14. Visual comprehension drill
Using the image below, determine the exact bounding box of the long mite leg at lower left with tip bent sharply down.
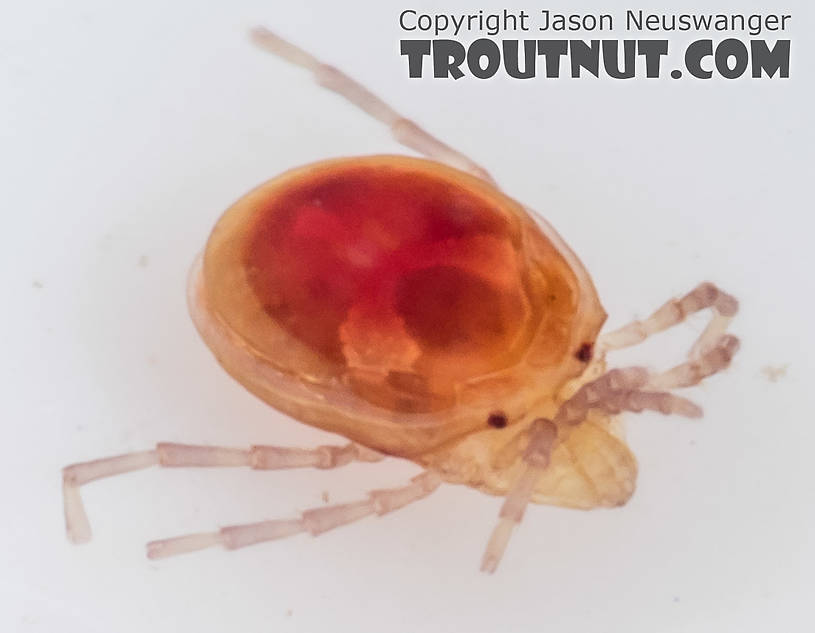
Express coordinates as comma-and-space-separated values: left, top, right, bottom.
62, 443, 383, 543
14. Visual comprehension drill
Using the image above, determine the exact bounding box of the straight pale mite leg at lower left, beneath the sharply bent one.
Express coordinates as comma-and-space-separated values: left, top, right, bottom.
147, 471, 441, 558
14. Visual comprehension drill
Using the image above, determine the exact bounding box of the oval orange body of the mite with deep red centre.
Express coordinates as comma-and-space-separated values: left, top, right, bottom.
191, 156, 605, 457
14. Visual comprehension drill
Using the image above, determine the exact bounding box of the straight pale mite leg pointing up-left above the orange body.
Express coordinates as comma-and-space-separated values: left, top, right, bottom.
251, 27, 495, 184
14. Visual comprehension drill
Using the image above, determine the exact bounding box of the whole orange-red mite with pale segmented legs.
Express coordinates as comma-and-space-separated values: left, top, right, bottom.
63, 29, 738, 572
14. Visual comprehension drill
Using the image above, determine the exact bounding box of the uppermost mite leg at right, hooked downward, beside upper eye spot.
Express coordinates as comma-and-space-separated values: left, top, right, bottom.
597, 282, 739, 359
